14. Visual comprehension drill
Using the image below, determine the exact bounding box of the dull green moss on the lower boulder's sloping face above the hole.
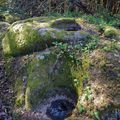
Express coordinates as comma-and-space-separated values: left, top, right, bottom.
25, 53, 75, 109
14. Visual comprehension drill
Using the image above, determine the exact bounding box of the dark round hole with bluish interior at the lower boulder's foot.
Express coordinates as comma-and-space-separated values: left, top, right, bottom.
46, 99, 75, 120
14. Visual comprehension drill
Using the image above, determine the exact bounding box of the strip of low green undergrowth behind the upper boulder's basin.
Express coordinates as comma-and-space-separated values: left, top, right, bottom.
45, 10, 120, 26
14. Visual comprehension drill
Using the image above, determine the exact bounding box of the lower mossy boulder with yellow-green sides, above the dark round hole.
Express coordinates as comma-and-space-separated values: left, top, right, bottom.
14, 48, 88, 110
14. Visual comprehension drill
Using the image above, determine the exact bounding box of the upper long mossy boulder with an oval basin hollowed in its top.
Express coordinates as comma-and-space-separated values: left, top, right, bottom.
2, 17, 89, 56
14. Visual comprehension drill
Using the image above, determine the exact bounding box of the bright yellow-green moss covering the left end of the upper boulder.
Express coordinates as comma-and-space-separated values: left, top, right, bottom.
3, 25, 44, 56
